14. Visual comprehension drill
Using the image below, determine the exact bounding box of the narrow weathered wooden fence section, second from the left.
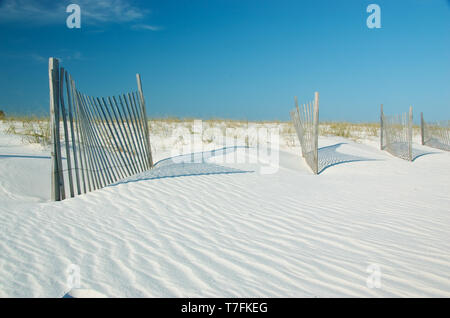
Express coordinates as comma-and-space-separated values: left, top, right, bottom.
291, 92, 319, 174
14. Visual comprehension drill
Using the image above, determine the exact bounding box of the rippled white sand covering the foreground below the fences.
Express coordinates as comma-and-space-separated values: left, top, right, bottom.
0, 121, 450, 297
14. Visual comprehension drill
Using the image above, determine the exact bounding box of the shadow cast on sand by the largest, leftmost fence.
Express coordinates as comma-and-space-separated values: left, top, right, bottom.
108, 147, 254, 187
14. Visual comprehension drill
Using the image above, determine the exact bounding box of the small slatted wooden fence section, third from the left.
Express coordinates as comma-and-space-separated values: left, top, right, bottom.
380, 105, 413, 161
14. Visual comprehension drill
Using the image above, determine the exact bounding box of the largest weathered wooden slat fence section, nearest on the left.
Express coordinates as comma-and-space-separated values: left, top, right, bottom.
49, 58, 153, 201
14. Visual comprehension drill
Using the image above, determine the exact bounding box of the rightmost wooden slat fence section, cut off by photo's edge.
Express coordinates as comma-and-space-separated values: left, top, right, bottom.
420, 113, 450, 151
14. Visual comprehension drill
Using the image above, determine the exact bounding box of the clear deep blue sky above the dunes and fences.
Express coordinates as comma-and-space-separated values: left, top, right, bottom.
0, 0, 450, 121
